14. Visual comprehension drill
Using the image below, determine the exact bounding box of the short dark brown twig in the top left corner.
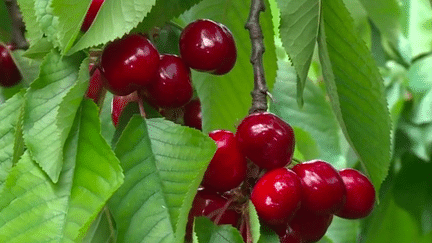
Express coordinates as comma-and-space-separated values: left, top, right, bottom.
4, 0, 28, 49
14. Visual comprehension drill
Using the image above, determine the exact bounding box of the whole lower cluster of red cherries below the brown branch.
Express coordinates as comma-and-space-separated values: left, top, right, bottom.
190, 112, 375, 243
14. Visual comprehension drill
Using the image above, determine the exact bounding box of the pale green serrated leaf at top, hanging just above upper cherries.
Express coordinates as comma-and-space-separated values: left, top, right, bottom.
68, 0, 156, 54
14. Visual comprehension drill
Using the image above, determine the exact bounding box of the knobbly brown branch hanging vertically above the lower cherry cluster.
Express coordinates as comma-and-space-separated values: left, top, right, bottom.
245, 0, 268, 114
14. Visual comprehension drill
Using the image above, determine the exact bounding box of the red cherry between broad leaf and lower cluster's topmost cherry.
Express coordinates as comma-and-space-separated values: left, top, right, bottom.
202, 130, 247, 192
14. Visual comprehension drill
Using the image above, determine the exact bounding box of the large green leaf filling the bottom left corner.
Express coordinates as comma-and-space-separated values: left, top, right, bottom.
0, 100, 123, 243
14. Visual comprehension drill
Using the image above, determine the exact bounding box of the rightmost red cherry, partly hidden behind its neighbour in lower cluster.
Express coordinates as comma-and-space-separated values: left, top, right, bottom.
336, 169, 375, 219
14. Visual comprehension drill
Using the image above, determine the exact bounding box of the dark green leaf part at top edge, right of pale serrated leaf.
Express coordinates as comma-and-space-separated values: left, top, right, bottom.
136, 0, 202, 32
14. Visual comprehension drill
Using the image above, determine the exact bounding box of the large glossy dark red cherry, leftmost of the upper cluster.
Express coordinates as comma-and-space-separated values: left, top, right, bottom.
101, 34, 159, 96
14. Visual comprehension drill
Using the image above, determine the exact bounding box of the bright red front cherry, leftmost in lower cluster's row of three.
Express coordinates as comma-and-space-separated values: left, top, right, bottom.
251, 168, 302, 225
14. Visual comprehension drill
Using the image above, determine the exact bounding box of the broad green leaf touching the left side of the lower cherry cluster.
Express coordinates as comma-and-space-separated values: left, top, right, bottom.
109, 116, 216, 242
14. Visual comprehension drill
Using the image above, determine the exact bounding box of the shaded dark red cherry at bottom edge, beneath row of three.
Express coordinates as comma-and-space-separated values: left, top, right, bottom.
289, 208, 333, 243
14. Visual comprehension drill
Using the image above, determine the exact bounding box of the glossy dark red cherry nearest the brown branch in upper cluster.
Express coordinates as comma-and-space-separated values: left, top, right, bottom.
179, 19, 237, 75
